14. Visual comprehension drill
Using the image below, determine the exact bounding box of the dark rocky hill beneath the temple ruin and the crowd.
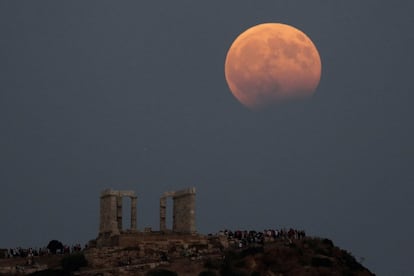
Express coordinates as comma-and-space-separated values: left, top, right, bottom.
0, 232, 374, 276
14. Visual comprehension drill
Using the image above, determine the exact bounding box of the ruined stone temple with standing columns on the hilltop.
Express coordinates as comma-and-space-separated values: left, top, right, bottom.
96, 188, 197, 247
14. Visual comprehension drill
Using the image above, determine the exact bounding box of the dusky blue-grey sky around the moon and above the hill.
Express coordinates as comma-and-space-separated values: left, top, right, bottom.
0, 0, 414, 275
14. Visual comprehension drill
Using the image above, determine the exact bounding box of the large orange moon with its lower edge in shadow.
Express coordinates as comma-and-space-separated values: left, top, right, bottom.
225, 23, 321, 110
